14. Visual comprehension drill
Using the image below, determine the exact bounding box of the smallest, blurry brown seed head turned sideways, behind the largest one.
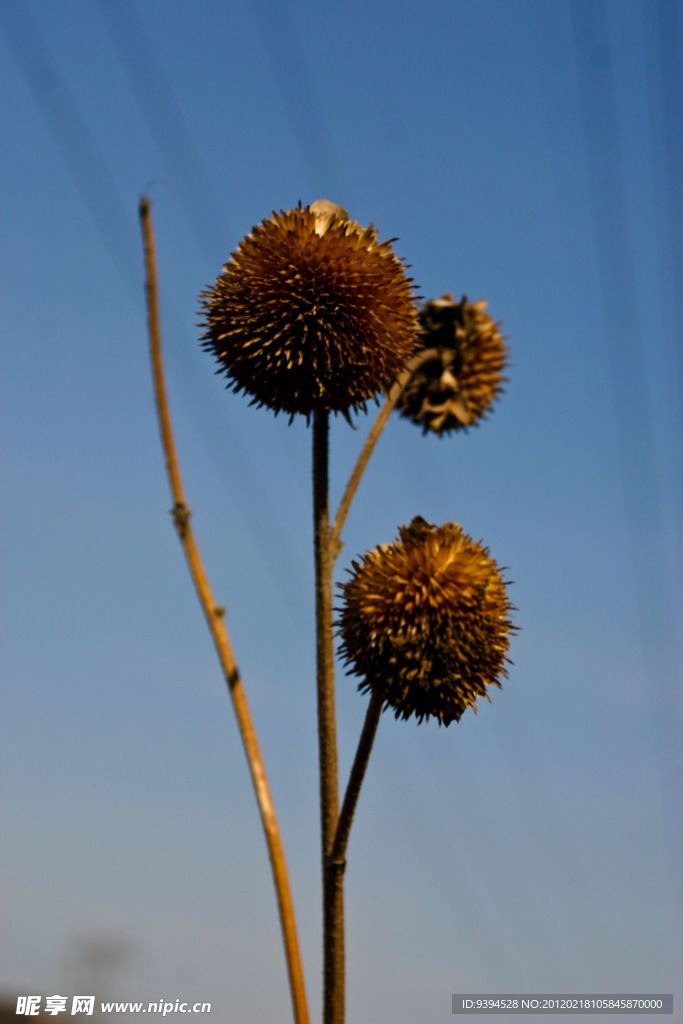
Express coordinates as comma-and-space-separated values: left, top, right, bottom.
398, 294, 508, 435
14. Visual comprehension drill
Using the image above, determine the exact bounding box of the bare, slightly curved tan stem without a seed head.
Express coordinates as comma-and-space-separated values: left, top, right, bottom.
139, 197, 308, 1024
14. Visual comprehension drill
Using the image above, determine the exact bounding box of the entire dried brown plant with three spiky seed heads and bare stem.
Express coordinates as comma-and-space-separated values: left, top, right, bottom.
140, 199, 515, 1024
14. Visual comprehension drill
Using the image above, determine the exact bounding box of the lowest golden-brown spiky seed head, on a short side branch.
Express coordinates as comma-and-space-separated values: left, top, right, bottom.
339, 516, 515, 725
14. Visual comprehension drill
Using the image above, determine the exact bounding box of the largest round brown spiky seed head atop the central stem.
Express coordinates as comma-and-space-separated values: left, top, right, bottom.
201, 200, 418, 417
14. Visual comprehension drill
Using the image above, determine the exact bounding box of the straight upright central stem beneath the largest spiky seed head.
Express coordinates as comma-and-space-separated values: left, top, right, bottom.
313, 411, 344, 1024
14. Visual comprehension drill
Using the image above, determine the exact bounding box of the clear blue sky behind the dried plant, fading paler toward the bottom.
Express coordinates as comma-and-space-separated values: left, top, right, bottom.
0, 0, 683, 1024
